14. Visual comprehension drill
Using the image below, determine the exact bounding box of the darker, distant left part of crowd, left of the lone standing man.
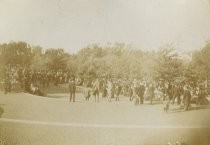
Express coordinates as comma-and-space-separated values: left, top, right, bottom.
0, 65, 80, 95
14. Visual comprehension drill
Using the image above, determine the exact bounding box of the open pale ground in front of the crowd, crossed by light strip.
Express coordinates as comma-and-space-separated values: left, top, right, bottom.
0, 85, 210, 145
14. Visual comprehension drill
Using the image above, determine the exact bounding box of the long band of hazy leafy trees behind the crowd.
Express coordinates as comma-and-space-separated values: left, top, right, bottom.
0, 42, 210, 83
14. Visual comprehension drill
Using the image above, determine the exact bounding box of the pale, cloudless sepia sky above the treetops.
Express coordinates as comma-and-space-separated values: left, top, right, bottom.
0, 0, 210, 52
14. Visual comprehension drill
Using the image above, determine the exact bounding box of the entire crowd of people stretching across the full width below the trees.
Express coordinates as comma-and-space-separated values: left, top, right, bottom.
1, 66, 208, 112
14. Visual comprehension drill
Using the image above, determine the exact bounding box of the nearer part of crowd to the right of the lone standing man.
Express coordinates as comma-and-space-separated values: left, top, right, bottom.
80, 78, 208, 112
